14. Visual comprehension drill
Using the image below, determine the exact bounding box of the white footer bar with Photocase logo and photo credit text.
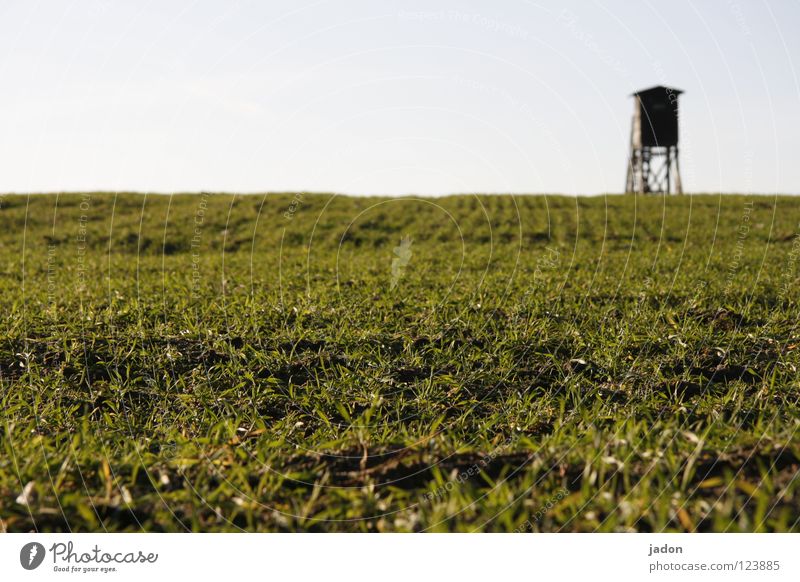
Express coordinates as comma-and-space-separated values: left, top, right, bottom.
0, 534, 800, 582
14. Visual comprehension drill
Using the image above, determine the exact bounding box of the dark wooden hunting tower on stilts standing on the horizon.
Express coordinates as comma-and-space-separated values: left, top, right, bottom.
625, 85, 683, 194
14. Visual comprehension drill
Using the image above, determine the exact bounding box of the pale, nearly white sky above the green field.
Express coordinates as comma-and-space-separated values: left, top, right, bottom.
0, 0, 800, 195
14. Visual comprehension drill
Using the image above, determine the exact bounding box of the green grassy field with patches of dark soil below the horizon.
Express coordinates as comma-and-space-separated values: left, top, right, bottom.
0, 193, 800, 532
